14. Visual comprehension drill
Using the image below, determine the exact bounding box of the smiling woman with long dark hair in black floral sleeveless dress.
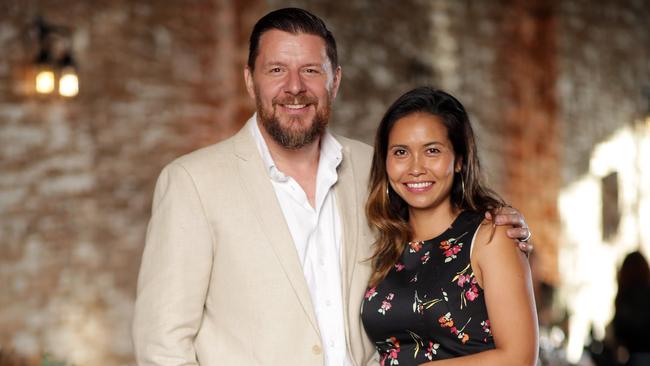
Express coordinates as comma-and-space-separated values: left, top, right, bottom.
361, 87, 538, 366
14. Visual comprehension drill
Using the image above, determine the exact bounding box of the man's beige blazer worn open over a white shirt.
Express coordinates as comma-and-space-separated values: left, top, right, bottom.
133, 123, 374, 366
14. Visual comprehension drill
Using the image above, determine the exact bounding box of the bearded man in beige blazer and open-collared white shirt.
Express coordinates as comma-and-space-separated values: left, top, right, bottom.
133, 8, 528, 366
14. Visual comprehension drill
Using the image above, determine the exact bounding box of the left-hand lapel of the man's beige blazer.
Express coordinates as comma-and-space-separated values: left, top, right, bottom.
233, 125, 320, 336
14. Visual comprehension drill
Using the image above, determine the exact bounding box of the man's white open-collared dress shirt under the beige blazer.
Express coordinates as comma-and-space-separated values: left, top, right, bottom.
248, 114, 352, 366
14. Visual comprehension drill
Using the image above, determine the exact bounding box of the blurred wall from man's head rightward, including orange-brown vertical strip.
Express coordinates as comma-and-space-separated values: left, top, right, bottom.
271, 0, 560, 283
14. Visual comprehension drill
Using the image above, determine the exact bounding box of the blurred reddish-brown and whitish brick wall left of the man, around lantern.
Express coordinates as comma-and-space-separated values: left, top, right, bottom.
0, 0, 263, 365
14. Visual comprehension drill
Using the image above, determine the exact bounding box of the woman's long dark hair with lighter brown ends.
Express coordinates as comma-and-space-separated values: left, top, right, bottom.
366, 87, 504, 286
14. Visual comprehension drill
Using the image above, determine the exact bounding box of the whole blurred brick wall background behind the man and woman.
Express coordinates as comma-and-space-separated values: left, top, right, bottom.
0, 0, 650, 366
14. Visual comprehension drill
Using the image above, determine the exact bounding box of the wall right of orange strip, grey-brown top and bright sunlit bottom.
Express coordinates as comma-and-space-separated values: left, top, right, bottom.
557, 0, 650, 362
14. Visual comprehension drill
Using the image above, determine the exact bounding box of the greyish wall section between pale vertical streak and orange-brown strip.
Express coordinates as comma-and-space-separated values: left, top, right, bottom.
431, 0, 508, 189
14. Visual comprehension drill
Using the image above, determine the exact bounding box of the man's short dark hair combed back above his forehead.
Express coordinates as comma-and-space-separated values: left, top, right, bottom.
248, 8, 339, 71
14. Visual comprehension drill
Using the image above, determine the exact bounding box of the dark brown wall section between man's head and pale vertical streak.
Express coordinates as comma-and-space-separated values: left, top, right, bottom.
269, 0, 433, 143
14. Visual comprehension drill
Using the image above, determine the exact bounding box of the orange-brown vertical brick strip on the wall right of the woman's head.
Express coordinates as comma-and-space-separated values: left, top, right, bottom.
497, 0, 561, 284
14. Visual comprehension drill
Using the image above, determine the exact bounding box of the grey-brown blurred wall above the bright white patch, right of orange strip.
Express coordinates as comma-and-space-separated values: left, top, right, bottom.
557, 0, 650, 185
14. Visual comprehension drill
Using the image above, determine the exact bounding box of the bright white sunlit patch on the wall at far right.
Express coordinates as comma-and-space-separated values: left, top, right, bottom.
558, 119, 650, 363
